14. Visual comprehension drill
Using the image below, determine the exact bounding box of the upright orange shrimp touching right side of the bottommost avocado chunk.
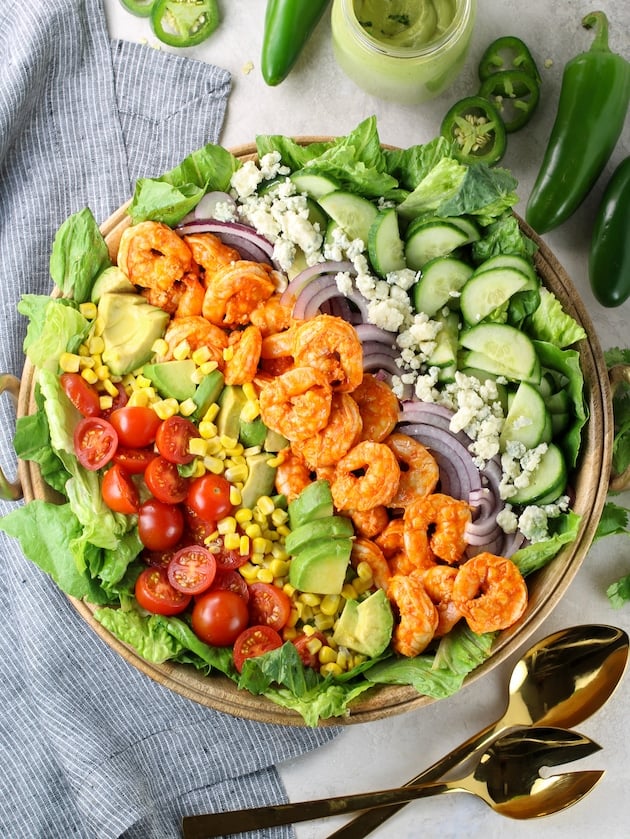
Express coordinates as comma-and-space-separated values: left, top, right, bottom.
386, 574, 438, 658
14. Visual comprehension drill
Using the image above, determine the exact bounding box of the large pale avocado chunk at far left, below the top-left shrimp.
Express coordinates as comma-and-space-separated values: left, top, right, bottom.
98, 292, 170, 376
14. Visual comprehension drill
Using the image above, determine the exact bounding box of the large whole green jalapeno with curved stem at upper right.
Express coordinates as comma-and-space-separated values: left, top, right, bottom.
525, 12, 630, 233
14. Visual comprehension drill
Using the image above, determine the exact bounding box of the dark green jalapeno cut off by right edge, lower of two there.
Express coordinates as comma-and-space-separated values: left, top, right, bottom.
588, 157, 630, 307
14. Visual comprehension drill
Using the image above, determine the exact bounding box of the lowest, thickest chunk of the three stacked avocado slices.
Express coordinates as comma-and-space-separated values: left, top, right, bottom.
289, 539, 352, 594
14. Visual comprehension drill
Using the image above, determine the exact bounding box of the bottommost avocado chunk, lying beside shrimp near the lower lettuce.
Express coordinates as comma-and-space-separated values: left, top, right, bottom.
333, 589, 394, 658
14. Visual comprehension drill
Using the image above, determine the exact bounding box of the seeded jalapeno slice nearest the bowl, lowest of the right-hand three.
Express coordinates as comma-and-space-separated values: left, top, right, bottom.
441, 96, 507, 166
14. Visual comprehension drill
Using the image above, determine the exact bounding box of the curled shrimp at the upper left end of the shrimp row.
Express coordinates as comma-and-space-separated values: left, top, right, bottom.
117, 221, 197, 291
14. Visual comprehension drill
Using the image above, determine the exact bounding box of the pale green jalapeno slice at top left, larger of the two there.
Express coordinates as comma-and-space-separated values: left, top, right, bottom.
151, 0, 219, 47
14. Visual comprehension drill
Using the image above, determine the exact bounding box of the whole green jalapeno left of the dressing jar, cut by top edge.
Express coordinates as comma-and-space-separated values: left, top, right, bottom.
260, 0, 330, 86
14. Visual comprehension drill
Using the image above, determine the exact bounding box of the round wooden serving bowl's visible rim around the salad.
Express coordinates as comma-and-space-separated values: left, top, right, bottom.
11, 137, 613, 726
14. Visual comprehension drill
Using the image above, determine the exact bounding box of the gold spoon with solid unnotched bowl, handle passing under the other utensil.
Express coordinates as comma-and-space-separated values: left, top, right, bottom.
328, 624, 629, 839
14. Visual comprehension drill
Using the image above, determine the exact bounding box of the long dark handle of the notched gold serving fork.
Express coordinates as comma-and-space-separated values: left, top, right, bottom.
182, 781, 454, 839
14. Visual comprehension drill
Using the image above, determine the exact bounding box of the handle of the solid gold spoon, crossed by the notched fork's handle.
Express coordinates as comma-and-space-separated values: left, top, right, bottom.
328, 719, 509, 839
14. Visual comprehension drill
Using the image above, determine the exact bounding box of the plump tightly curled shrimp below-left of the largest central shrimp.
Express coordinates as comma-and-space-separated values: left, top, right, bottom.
259, 367, 332, 442
